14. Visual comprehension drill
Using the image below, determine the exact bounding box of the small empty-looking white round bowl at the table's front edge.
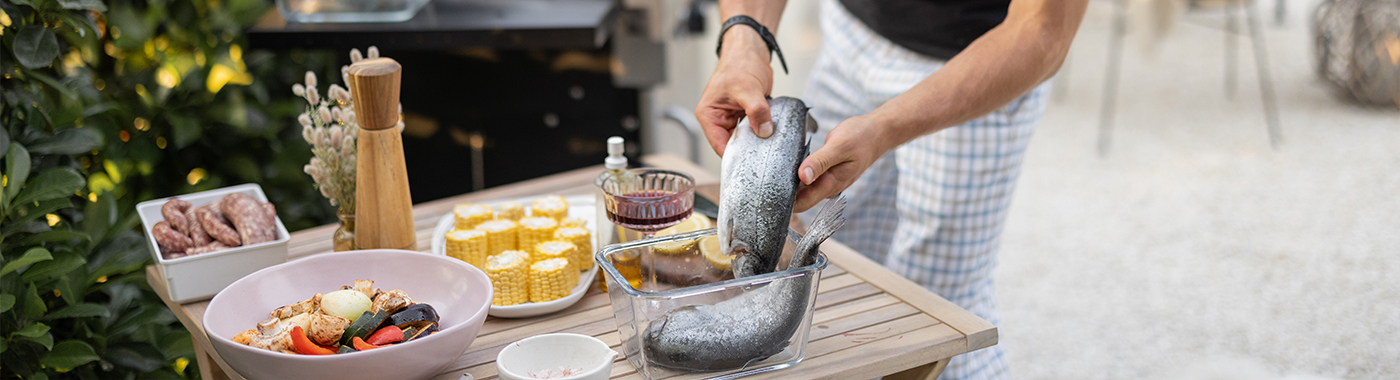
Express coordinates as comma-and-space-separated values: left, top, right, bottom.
496, 334, 617, 380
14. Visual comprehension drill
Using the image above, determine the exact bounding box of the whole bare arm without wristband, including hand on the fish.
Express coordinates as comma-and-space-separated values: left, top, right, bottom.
794, 0, 1088, 210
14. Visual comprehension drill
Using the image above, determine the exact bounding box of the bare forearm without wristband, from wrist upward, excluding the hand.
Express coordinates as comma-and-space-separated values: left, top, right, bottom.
871, 0, 1088, 149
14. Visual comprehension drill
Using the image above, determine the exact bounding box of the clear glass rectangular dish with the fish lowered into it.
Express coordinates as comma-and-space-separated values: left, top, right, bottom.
594, 229, 826, 379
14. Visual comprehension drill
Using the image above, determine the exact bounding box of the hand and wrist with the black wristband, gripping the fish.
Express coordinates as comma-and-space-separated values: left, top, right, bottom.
696, 0, 787, 156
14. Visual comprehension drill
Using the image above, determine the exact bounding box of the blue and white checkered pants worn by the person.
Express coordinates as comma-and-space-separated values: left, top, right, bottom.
804, 0, 1050, 379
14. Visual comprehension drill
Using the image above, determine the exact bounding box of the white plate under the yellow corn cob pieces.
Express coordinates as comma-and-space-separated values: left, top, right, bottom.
431, 195, 598, 318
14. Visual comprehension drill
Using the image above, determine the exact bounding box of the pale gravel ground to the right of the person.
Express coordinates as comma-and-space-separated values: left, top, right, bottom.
998, 1, 1400, 380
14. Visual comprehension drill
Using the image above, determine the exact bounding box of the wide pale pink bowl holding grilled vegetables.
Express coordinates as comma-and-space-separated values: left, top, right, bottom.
204, 250, 491, 379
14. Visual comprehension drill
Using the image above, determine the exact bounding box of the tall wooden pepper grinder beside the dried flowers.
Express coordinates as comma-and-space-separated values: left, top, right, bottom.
349, 57, 419, 251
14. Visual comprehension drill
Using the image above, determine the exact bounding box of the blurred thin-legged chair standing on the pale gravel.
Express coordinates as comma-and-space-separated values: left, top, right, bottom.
1099, 0, 1284, 156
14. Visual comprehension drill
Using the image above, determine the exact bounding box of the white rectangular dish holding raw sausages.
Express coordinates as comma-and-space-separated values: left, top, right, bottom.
136, 184, 290, 303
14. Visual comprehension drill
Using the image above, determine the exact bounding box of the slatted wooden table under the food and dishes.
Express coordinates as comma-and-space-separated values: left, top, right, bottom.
146, 156, 997, 380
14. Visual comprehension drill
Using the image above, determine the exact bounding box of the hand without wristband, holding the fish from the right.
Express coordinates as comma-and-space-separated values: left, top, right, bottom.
792, 115, 897, 212
